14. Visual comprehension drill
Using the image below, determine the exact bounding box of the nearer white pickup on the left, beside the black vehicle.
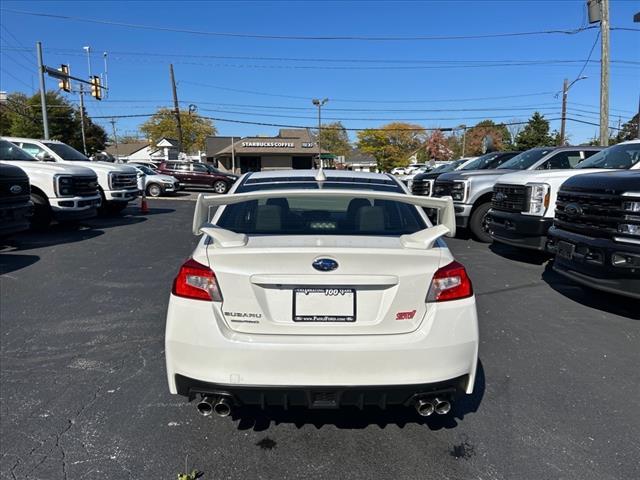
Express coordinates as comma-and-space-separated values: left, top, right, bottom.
0, 138, 101, 228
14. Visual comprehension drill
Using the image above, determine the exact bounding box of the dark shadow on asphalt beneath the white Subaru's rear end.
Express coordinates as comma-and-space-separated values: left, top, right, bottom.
232, 361, 485, 432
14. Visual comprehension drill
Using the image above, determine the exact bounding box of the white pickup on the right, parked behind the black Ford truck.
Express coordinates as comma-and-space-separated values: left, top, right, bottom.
487, 140, 640, 251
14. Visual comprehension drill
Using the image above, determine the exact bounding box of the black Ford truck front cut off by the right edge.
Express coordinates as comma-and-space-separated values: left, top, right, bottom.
547, 170, 640, 299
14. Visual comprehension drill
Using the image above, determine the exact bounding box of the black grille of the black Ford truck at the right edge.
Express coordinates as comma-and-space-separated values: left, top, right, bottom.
554, 189, 624, 238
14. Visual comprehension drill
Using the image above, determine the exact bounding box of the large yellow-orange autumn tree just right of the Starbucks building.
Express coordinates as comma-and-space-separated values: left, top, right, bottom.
357, 122, 425, 172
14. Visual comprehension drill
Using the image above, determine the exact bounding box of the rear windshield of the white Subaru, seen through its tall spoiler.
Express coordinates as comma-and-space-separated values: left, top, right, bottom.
217, 195, 427, 236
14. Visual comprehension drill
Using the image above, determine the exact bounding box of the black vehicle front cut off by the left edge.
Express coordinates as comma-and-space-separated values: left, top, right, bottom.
0, 163, 33, 236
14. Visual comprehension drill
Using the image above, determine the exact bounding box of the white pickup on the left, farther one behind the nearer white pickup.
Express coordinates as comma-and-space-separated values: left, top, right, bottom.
5, 137, 138, 212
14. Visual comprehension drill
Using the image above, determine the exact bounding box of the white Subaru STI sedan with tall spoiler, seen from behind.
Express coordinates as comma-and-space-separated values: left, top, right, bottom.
166, 170, 478, 416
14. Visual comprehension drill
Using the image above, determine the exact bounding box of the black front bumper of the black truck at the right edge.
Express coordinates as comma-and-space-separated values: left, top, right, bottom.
547, 227, 640, 299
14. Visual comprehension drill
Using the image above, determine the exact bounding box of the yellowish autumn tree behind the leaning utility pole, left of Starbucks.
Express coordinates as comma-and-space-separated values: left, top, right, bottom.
140, 108, 216, 153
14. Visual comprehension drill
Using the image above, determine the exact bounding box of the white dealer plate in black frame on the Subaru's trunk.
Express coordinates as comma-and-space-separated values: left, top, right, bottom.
293, 288, 356, 322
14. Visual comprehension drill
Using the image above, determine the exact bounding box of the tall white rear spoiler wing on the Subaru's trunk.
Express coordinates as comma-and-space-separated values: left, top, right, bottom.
193, 189, 456, 248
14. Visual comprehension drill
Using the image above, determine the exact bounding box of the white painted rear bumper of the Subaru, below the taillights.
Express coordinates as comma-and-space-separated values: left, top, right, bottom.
165, 295, 478, 400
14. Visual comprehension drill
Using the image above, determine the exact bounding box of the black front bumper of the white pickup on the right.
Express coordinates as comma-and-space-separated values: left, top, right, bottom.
488, 209, 553, 251
